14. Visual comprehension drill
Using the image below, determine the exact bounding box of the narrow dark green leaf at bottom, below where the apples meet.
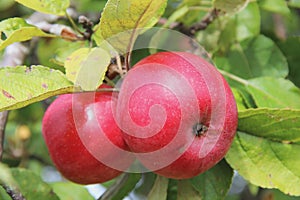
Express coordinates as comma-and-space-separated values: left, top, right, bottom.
111, 173, 141, 200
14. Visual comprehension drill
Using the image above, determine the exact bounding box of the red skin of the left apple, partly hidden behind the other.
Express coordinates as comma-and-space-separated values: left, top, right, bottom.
42, 85, 132, 184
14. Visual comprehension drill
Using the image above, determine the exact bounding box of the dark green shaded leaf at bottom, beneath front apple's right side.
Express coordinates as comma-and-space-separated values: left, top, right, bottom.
189, 160, 233, 200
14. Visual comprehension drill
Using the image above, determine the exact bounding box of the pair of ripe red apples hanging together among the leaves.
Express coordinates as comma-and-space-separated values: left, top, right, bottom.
42, 52, 238, 184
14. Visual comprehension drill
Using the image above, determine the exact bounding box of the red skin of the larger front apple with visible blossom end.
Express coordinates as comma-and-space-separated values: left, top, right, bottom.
117, 52, 238, 179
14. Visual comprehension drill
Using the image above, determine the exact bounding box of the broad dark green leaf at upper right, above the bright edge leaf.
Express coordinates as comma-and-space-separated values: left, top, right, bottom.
214, 35, 288, 79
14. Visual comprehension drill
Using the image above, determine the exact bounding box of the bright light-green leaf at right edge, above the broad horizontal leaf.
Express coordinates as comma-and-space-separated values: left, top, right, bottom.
247, 77, 300, 109
